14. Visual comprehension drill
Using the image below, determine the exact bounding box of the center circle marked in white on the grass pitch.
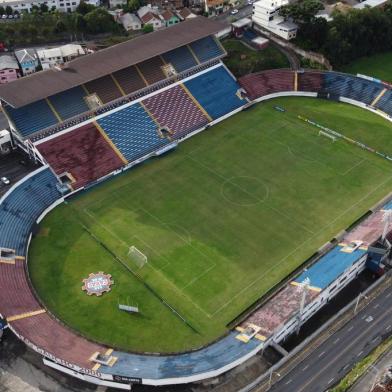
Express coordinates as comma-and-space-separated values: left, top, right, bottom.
221, 176, 269, 207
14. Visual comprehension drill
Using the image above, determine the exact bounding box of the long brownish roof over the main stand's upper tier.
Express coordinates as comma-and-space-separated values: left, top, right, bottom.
0, 16, 223, 108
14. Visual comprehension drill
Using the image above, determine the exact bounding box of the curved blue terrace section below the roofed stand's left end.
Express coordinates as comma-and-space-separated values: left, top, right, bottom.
0, 169, 61, 256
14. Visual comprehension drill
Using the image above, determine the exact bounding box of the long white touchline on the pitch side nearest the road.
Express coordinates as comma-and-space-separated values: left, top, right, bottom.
212, 171, 392, 316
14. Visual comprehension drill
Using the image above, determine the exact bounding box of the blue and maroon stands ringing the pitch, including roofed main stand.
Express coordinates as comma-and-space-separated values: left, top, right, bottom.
0, 14, 392, 389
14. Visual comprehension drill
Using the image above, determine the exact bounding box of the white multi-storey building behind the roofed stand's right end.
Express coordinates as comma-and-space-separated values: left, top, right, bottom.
252, 0, 298, 40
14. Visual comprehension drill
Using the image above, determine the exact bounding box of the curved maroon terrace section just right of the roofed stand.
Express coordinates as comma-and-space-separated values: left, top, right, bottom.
239, 69, 294, 99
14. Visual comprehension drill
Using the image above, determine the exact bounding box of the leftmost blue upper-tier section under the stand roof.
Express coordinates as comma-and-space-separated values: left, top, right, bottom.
5, 99, 58, 136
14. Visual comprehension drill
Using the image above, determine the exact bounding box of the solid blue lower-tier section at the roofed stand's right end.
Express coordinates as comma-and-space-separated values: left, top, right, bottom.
185, 66, 246, 119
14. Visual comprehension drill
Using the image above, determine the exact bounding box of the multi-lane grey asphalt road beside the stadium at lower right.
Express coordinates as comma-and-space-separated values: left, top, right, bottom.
270, 287, 392, 392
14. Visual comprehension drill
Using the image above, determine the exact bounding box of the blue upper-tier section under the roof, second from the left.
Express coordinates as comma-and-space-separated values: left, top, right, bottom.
49, 86, 89, 120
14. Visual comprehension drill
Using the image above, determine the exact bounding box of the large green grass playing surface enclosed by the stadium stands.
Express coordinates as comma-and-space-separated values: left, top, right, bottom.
29, 98, 392, 352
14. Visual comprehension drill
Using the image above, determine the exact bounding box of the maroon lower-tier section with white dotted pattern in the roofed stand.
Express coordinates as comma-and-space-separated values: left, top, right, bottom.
143, 86, 208, 137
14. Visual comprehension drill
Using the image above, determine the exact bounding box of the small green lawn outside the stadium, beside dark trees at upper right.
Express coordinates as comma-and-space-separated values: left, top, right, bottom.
342, 52, 392, 83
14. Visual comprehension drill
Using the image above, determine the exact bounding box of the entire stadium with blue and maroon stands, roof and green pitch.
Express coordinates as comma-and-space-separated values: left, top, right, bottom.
0, 17, 392, 390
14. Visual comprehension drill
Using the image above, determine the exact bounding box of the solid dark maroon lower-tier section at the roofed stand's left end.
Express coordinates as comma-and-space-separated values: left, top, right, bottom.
37, 123, 123, 189
